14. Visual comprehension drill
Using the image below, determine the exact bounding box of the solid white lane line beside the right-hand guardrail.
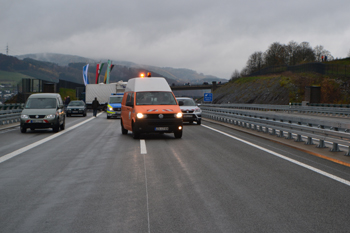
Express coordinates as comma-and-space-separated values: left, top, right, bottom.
202, 124, 350, 186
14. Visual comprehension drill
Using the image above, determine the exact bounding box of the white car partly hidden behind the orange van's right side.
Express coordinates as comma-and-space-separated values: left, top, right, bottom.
176, 97, 202, 125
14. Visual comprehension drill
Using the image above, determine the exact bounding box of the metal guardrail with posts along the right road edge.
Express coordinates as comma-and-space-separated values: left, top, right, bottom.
201, 105, 350, 156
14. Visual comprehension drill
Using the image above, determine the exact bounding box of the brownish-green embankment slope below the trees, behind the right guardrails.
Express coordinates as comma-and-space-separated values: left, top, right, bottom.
213, 58, 350, 105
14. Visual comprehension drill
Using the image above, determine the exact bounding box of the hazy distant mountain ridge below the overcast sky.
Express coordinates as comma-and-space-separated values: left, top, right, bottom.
16, 53, 227, 84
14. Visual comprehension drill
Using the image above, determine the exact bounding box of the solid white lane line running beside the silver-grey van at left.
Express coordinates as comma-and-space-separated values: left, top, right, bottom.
0, 117, 95, 163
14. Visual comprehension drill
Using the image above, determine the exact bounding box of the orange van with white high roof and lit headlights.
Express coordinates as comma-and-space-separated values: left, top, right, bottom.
120, 77, 183, 138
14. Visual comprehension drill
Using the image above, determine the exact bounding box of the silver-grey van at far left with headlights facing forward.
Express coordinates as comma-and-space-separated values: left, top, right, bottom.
21, 93, 66, 133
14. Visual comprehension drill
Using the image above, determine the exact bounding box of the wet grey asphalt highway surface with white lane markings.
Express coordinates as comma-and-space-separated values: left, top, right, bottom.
0, 112, 350, 233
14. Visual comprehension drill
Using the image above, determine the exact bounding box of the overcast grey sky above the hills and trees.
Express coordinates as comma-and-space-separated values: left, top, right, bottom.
0, 0, 350, 79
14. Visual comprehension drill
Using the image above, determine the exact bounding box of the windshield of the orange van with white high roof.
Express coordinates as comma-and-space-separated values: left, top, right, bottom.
136, 92, 177, 105
